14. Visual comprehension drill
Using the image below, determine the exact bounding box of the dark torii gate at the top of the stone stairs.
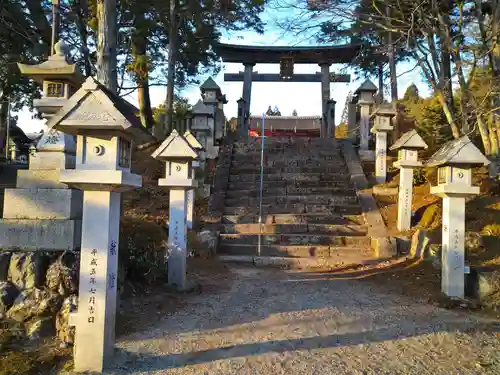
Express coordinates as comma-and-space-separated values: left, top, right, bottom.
215, 44, 361, 138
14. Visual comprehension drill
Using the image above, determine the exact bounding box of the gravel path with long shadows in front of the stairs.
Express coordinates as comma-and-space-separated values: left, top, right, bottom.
111, 267, 500, 375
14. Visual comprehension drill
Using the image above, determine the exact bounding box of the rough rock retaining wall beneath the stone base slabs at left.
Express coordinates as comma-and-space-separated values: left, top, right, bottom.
0, 251, 80, 344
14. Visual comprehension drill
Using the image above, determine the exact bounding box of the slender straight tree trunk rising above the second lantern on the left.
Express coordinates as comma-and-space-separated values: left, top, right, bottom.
165, 0, 177, 133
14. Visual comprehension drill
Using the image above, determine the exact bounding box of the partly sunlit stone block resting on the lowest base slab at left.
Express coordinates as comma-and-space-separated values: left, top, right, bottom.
3, 188, 83, 220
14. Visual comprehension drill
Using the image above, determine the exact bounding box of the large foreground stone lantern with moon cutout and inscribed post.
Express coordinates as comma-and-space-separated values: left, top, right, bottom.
48, 78, 152, 372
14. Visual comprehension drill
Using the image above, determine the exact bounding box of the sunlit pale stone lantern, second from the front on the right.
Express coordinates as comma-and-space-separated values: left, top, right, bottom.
391, 130, 427, 231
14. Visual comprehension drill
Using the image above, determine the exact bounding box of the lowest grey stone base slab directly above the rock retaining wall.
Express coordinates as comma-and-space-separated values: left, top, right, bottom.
0, 219, 82, 251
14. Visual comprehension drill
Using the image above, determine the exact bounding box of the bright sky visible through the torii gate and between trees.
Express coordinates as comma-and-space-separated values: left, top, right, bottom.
18, 6, 429, 133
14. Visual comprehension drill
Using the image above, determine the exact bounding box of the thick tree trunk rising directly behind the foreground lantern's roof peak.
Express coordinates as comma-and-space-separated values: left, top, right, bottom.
97, 0, 118, 93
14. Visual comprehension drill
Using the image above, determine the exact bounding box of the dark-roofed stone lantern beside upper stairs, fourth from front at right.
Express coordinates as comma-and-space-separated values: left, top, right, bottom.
355, 79, 378, 160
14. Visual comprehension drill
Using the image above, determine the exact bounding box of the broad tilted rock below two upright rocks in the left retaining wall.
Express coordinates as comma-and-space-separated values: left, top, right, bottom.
7, 288, 62, 322
